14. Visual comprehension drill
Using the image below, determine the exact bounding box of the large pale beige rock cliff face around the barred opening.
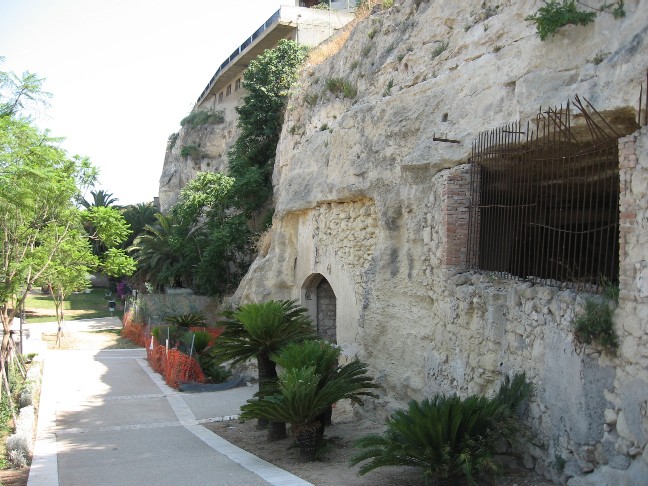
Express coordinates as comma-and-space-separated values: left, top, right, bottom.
235, 0, 648, 484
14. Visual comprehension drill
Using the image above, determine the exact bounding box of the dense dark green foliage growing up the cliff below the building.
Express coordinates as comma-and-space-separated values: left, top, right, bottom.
130, 40, 306, 295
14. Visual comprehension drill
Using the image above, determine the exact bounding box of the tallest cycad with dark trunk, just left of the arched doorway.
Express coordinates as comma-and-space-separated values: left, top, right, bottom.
213, 300, 315, 441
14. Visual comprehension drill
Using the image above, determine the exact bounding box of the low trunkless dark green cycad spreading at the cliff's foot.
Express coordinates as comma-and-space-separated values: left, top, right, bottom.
350, 374, 532, 484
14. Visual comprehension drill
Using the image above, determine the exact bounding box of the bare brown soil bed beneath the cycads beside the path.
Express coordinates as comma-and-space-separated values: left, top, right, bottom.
206, 420, 553, 486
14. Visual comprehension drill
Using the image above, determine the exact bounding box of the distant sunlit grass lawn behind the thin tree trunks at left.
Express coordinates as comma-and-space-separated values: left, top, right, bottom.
25, 289, 121, 322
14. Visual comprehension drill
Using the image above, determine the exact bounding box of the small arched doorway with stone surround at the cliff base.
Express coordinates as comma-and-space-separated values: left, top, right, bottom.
302, 273, 337, 343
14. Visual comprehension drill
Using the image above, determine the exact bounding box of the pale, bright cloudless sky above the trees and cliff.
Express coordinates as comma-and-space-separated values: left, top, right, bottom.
0, 0, 294, 205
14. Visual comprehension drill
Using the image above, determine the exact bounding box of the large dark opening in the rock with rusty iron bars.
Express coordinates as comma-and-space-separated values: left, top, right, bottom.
466, 97, 619, 292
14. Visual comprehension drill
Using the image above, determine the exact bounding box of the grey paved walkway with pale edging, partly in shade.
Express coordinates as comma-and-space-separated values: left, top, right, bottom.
28, 320, 310, 486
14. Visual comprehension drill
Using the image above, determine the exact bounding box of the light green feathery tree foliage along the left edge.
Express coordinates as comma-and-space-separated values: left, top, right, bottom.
0, 62, 132, 351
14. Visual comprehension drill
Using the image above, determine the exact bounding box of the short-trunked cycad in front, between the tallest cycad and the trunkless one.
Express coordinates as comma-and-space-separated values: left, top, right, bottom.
241, 361, 376, 461
